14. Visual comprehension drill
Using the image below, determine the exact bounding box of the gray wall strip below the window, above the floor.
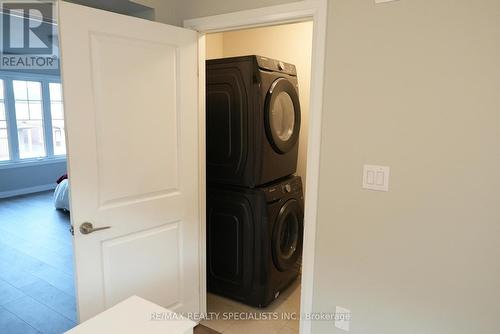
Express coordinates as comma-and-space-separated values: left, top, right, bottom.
0, 161, 66, 198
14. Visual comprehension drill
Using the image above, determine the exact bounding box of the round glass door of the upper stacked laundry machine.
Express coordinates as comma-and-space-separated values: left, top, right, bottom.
264, 78, 300, 154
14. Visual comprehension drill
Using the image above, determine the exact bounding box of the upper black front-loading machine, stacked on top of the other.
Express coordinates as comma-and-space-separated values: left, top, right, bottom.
206, 56, 300, 187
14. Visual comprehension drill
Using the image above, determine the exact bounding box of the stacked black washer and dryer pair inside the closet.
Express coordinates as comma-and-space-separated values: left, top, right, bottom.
206, 56, 304, 307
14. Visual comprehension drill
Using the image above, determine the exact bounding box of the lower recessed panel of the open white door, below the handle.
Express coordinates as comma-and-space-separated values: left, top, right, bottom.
101, 220, 184, 308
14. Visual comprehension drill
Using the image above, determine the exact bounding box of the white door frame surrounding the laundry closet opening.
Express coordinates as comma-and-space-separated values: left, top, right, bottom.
184, 0, 327, 334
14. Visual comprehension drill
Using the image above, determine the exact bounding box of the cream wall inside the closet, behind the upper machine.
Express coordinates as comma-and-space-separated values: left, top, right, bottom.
206, 22, 313, 182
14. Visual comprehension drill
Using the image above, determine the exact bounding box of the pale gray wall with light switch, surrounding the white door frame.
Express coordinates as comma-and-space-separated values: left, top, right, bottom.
141, 0, 500, 334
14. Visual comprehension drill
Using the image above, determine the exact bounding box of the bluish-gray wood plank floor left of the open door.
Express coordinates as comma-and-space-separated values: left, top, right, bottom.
0, 191, 76, 334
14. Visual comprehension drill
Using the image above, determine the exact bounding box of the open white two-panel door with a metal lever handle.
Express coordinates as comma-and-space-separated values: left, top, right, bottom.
59, 2, 200, 321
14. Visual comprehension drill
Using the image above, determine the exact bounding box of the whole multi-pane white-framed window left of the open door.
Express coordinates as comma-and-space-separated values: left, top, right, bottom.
0, 73, 66, 163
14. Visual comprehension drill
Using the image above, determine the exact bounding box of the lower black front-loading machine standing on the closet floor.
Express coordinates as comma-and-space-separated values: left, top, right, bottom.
207, 176, 304, 307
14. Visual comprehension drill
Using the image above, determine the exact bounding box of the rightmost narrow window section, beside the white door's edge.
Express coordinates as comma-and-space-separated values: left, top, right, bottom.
49, 82, 66, 155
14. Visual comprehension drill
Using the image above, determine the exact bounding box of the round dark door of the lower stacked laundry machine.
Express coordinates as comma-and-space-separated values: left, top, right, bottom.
272, 199, 304, 271
